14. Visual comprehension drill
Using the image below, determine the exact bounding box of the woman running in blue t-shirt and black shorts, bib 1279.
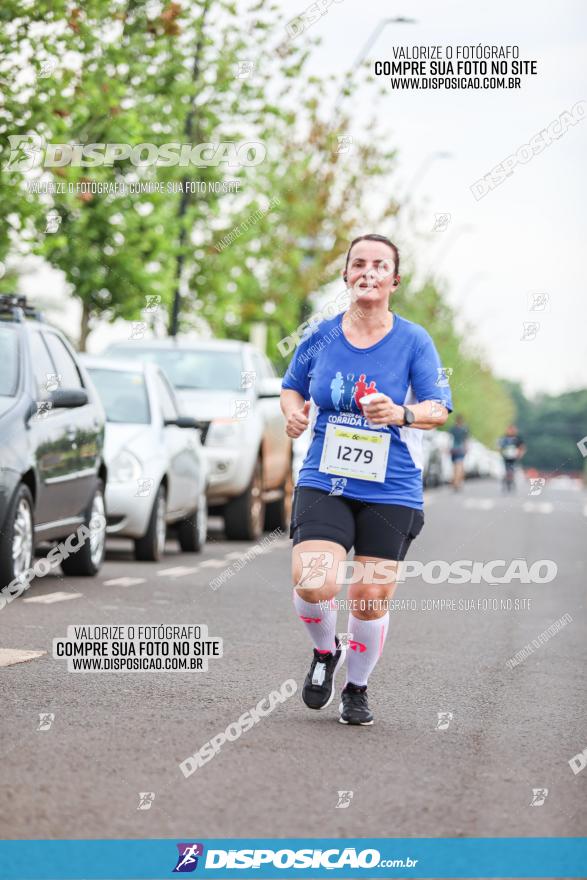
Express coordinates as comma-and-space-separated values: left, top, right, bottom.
281, 234, 452, 724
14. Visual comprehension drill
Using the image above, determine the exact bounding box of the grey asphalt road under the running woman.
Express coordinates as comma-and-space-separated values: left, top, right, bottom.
0, 481, 587, 840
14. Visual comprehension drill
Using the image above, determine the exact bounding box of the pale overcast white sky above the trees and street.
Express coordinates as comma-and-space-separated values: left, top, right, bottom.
19, 0, 587, 395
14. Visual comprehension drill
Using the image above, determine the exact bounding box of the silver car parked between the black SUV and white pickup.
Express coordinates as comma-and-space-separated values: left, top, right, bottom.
82, 357, 208, 561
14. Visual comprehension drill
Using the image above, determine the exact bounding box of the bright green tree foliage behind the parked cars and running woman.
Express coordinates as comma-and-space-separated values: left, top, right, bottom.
0, 0, 524, 445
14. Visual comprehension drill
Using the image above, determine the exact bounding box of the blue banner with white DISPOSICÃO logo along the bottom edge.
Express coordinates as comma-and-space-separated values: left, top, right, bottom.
0, 837, 587, 880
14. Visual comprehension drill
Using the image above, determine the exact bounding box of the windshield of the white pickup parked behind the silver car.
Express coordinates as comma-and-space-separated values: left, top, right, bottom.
111, 346, 243, 391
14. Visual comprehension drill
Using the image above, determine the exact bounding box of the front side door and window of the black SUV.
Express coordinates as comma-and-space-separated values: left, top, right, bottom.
28, 328, 80, 524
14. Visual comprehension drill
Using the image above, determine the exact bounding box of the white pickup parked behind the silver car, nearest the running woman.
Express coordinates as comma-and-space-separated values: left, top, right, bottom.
107, 337, 292, 541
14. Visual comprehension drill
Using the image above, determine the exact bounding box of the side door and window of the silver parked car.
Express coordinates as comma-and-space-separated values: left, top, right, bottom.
153, 368, 198, 517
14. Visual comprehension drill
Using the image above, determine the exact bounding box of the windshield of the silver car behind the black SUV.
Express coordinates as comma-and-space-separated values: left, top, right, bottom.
88, 367, 151, 425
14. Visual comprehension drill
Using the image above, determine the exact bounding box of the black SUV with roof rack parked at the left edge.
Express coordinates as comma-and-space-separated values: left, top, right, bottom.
0, 295, 106, 588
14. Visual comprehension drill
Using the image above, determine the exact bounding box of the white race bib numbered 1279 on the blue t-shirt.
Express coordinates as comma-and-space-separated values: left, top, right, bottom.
319, 423, 391, 483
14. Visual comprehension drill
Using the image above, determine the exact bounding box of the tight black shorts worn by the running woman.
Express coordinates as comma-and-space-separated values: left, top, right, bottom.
289, 486, 424, 561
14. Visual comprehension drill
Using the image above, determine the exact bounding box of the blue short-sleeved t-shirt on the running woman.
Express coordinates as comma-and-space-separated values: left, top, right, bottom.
282, 312, 452, 510
